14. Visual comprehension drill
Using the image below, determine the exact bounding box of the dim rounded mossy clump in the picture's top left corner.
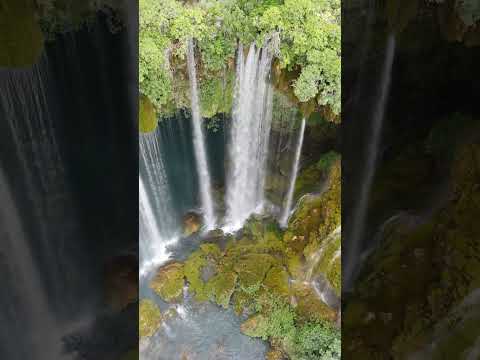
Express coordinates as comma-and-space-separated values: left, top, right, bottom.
0, 0, 44, 68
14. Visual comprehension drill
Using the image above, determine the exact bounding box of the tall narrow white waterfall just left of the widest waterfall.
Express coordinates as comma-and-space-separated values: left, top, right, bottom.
187, 39, 216, 230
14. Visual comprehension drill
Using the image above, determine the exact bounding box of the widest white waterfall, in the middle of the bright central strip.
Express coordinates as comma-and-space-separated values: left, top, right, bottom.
224, 44, 273, 231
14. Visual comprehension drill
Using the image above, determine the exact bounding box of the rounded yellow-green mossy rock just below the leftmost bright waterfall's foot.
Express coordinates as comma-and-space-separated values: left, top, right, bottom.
150, 262, 184, 302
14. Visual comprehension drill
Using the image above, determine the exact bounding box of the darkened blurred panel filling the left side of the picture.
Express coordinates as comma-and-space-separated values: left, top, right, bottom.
0, 0, 138, 359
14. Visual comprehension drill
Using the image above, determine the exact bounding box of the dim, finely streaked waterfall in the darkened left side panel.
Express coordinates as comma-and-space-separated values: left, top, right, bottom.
0, 53, 93, 326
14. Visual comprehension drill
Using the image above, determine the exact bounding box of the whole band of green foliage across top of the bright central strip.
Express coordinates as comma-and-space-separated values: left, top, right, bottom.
139, 0, 340, 117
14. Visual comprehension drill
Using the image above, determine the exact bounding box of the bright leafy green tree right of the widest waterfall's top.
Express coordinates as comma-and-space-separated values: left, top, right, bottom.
260, 0, 341, 114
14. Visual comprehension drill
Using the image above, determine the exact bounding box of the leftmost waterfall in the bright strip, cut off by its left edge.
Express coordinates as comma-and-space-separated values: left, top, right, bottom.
138, 129, 178, 276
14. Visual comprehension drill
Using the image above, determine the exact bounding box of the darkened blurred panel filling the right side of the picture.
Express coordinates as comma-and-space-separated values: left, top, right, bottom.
342, 0, 480, 359
